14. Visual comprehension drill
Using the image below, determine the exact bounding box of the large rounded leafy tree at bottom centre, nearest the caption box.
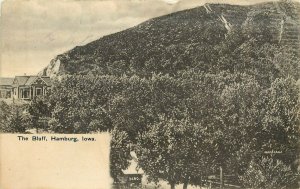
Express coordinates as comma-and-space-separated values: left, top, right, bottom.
137, 116, 208, 189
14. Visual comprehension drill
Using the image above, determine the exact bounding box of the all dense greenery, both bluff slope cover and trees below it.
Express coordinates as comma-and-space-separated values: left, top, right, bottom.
11, 2, 300, 188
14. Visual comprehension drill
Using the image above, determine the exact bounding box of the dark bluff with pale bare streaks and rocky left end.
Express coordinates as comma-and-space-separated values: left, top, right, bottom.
40, 2, 300, 77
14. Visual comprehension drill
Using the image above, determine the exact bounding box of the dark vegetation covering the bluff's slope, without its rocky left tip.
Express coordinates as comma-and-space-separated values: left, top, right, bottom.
45, 2, 299, 84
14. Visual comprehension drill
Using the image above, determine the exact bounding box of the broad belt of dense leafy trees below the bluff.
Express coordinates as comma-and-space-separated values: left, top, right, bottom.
28, 70, 299, 188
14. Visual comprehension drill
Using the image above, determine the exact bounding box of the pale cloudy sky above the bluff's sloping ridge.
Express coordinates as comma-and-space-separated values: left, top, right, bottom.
0, 0, 284, 77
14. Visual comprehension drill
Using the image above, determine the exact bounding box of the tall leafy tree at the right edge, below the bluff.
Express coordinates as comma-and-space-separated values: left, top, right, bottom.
258, 77, 300, 167
